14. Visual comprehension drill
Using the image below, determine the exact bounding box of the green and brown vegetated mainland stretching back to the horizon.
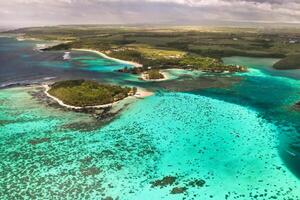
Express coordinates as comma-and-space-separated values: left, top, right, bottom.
5, 25, 300, 70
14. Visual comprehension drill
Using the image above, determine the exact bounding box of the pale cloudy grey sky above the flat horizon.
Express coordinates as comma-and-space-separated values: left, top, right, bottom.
0, 0, 300, 26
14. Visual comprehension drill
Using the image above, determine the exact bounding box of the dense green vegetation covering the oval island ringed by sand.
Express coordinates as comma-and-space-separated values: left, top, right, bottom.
48, 80, 132, 107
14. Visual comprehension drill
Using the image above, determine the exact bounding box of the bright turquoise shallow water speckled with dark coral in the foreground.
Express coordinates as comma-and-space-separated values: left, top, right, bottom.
0, 88, 300, 199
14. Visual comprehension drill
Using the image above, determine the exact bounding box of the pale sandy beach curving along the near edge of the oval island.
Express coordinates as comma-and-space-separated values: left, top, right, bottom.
43, 84, 153, 110
